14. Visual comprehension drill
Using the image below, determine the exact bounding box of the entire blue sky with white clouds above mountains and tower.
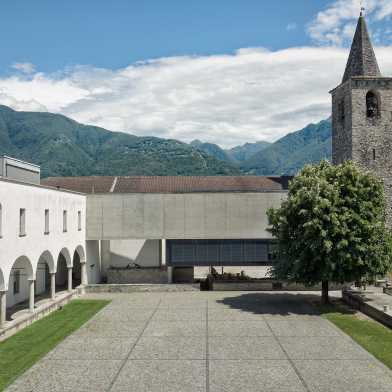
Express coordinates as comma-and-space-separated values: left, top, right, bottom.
0, 0, 392, 147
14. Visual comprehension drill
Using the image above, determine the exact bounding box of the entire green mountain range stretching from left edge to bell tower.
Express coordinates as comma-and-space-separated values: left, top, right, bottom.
0, 105, 331, 177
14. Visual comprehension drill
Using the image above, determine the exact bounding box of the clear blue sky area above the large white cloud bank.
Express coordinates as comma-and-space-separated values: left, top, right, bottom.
0, 0, 327, 73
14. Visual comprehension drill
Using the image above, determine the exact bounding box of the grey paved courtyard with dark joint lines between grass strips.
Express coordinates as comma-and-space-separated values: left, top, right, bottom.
4, 292, 392, 392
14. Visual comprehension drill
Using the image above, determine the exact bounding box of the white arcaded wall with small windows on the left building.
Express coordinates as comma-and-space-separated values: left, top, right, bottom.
0, 179, 86, 306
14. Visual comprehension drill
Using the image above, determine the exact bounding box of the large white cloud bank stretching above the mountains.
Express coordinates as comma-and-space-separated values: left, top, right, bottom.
0, 47, 392, 146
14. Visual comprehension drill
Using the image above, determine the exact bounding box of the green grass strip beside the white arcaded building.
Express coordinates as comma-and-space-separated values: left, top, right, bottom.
0, 300, 110, 391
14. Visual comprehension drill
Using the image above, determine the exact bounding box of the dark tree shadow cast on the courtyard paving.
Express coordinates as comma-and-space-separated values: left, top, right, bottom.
216, 292, 355, 316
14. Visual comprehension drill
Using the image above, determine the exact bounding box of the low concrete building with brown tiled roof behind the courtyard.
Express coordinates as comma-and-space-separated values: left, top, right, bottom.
45, 176, 288, 283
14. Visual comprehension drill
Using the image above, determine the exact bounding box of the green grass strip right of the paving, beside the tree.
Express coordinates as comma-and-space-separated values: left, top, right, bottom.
318, 304, 392, 369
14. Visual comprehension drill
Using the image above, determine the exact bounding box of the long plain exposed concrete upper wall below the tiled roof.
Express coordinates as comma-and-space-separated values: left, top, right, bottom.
87, 192, 286, 240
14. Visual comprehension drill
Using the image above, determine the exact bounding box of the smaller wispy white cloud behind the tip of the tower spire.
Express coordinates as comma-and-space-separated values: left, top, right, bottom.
308, 0, 392, 46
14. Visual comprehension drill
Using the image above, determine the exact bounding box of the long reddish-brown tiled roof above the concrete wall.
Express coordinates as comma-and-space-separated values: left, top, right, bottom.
42, 176, 288, 194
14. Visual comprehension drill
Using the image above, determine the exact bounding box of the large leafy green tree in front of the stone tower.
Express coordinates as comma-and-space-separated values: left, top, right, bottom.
268, 161, 392, 303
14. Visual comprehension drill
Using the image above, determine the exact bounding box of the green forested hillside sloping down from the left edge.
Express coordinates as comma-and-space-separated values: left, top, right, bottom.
0, 105, 240, 177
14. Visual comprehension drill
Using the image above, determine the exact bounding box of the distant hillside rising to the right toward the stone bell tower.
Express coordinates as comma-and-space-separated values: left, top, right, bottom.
240, 120, 332, 175
